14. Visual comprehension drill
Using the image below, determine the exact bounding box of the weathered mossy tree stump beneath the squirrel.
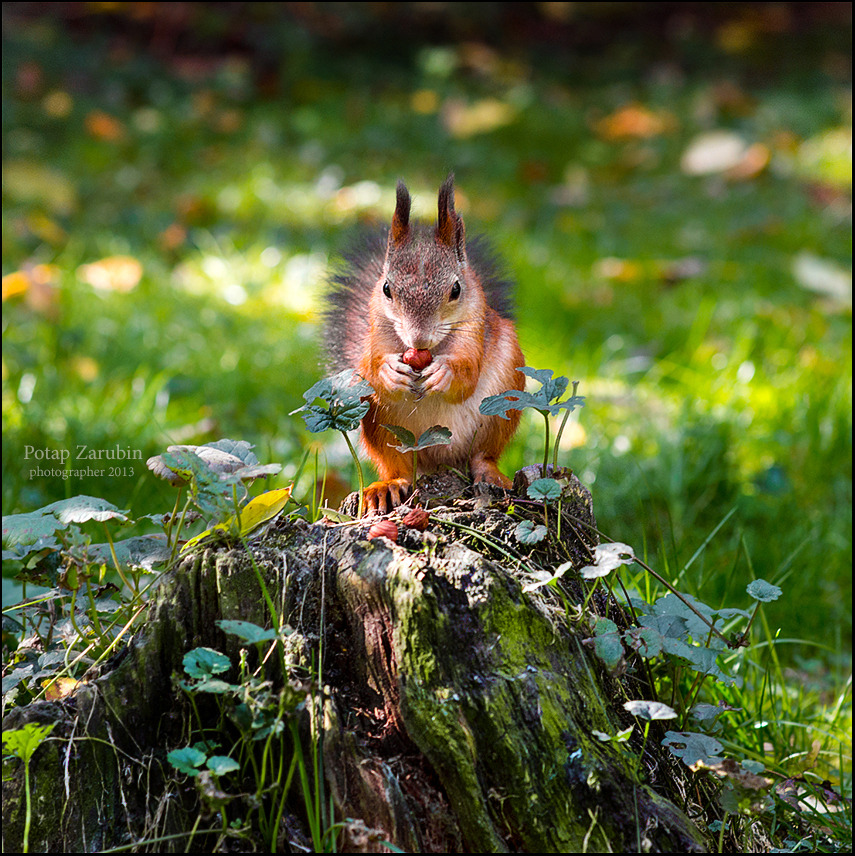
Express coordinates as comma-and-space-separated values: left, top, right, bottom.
3, 472, 705, 853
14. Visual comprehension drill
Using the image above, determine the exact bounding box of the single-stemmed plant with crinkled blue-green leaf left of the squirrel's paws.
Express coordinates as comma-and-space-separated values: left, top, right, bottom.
291, 369, 374, 517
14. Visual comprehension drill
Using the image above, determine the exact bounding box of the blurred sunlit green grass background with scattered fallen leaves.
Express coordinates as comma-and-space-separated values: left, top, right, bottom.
2, 2, 852, 660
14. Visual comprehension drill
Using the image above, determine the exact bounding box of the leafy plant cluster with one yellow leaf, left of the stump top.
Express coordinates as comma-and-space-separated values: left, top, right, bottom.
3, 440, 291, 705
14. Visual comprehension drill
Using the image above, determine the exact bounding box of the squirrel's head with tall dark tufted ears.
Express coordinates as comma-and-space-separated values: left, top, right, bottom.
372, 174, 486, 350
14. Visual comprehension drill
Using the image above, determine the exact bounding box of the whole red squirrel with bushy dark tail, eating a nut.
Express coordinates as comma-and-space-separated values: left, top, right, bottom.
324, 174, 525, 513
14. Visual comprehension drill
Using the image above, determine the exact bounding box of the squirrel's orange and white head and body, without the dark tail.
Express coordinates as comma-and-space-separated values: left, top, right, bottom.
338, 179, 525, 512
